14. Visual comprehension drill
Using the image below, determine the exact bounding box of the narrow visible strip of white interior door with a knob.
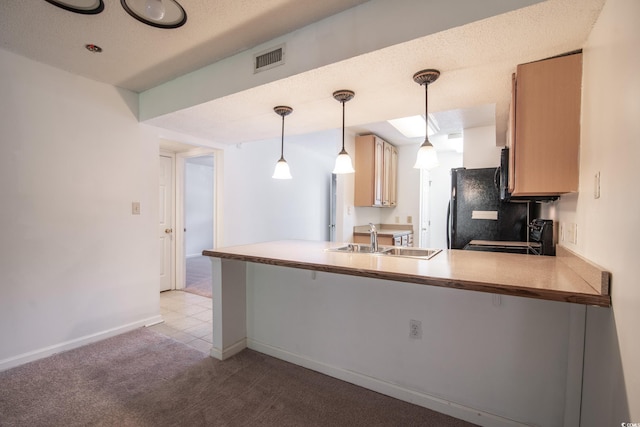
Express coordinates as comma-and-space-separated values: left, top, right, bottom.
158, 156, 175, 292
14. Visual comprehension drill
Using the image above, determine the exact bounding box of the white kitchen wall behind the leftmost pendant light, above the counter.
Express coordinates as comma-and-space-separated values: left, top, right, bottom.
222, 127, 339, 246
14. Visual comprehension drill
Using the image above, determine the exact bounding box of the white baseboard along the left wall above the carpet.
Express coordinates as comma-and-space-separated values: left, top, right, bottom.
0, 315, 162, 372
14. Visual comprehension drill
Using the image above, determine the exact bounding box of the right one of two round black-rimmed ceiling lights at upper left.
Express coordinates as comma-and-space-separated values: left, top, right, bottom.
120, 0, 187, 28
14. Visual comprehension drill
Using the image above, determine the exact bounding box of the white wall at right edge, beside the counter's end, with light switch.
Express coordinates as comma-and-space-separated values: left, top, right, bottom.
556, 0, 640, 427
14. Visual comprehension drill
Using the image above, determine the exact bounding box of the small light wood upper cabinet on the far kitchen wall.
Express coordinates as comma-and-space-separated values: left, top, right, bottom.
354, 135, 398, 207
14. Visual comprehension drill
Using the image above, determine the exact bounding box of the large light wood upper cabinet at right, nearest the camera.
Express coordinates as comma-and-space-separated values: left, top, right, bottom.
509, 53, 582, 196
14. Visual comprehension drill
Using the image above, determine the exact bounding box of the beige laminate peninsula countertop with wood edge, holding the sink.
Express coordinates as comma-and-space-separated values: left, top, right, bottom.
203, 240, 611, 307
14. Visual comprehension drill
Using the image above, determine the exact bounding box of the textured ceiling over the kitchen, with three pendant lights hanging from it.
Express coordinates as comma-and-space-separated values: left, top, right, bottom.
148, 0, 604, 149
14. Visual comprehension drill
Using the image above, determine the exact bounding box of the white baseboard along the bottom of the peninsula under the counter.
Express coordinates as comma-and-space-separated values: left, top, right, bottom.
247, 339, 525, 427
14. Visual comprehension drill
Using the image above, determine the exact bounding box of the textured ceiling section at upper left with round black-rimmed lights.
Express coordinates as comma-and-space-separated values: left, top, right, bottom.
0, 0, 366, 92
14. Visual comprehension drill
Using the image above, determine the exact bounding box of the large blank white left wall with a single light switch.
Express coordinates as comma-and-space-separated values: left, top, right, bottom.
0, 49, 159, 369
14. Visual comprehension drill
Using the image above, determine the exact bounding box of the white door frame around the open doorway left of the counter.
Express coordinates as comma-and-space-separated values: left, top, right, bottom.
174, 147, 224, 289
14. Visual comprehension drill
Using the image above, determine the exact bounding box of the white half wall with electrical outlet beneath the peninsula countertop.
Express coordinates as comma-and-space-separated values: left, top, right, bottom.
247, 264, 588, 427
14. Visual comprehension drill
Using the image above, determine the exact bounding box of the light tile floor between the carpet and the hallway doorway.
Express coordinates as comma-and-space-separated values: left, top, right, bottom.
150, 291, 213, 354
